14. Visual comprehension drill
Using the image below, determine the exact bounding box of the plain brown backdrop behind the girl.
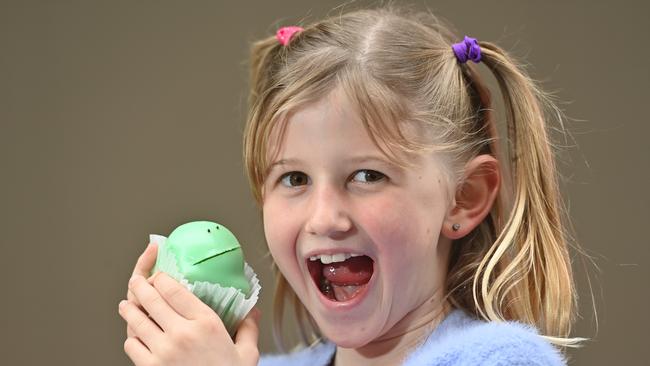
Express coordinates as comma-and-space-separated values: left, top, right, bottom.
0, 0, 650, 365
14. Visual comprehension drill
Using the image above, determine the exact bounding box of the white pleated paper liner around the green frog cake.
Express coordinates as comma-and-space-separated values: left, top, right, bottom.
149, 234, 262, 337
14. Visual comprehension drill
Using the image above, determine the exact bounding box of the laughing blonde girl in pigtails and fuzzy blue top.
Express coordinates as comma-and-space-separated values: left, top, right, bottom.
120, 6, 580, 366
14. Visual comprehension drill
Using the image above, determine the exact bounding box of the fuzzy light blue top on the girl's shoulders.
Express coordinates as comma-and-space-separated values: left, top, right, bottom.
260, 310, 566, 366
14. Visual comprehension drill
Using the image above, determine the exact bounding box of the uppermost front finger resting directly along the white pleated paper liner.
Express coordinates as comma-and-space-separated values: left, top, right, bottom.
154, 272, 214, 320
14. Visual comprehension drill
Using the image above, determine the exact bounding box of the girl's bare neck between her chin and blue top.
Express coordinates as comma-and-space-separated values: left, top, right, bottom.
334, 293, 451, 366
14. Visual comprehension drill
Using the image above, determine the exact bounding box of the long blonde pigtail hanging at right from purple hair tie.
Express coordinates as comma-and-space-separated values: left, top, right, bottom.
466, 42, 580, 346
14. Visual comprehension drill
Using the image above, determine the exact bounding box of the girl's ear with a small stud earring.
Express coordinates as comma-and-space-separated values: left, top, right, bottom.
442, 155, 501, 240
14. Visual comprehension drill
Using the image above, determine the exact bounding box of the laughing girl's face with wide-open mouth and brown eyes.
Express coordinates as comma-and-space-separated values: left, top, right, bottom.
263, 90, 450, 348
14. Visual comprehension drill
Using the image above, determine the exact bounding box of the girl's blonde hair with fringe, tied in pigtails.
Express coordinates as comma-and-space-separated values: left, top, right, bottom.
244, 4, 581, 349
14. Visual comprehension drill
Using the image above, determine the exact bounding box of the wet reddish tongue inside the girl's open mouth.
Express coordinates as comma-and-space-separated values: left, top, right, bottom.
323, 255, 373, 286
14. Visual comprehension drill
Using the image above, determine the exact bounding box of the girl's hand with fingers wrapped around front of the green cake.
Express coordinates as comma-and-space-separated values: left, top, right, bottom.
119, 274, 259, 366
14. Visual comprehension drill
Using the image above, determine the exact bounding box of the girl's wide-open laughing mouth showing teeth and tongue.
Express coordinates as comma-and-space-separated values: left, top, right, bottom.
307, 255, 374, 302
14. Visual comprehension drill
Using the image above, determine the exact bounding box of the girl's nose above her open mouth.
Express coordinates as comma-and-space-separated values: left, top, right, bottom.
305, 186, 352, 237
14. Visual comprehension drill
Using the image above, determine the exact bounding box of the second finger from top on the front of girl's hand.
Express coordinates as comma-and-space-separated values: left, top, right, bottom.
129, 276, 183, 331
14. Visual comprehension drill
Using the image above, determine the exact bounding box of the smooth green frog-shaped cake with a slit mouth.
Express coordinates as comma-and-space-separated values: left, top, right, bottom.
165, 221, 250, 294
